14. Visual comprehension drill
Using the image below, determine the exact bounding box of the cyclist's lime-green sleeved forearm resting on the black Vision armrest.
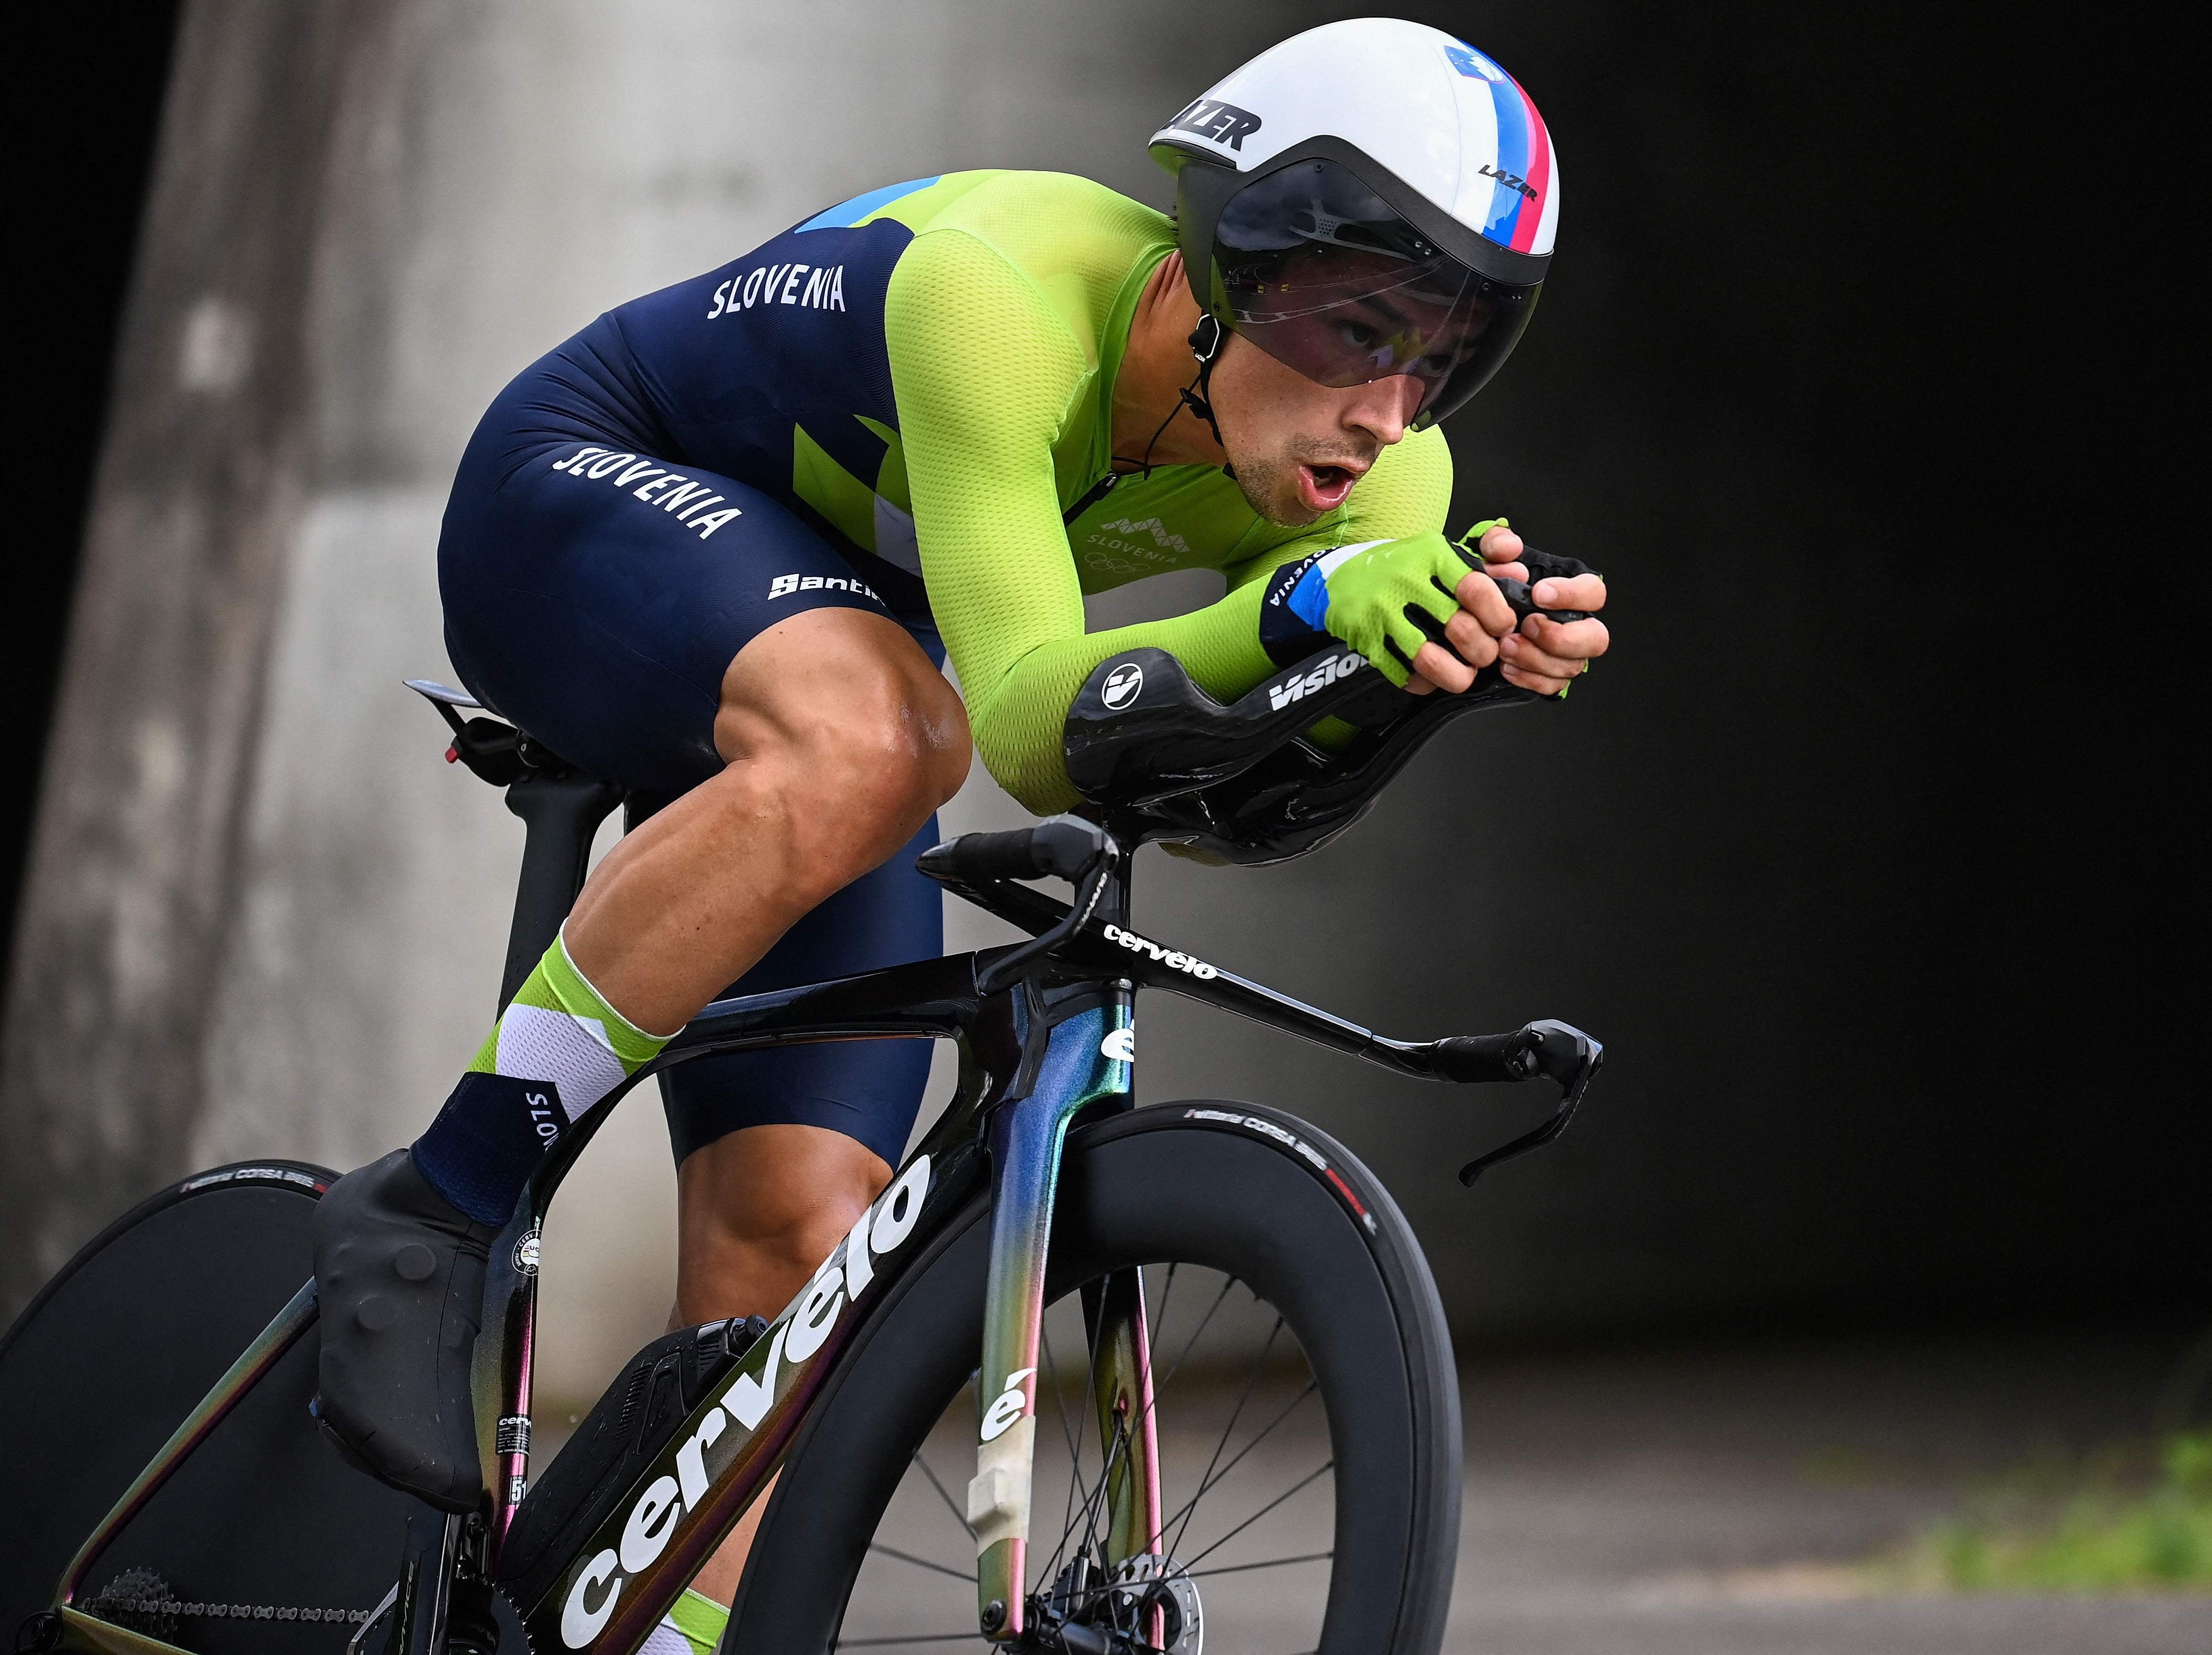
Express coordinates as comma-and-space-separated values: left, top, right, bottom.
962, 582, 1274, 816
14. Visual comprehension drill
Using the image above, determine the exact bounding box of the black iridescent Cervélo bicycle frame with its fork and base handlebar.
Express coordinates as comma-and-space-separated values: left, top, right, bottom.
55, 845, 1521, 1655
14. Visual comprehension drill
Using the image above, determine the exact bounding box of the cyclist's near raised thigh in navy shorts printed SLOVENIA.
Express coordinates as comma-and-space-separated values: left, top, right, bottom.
438, 433, 889, 794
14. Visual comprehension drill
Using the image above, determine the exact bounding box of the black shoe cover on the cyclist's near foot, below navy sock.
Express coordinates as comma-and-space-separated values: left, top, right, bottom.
314, 1148, 498, 1513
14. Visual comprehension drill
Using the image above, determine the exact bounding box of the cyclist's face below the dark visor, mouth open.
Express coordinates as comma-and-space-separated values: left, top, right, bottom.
1210, 334, 1427, 524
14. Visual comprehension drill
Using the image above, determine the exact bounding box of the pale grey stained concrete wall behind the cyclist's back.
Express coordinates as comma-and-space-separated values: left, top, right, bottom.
7, 0, 1353, 1392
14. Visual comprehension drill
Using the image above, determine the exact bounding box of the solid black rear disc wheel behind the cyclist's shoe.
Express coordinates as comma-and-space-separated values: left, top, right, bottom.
0, 1162, 414, 1655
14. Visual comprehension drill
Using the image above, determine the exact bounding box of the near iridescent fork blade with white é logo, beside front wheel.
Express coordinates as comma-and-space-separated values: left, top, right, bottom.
967, 995, 1133, 1642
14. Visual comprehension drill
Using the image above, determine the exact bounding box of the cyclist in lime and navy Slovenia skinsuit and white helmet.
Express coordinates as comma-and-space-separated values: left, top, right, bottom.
316, 18, 1606, 1637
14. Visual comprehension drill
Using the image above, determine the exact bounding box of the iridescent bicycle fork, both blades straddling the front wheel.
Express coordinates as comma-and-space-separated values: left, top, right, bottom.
967, 989, 1159, 1644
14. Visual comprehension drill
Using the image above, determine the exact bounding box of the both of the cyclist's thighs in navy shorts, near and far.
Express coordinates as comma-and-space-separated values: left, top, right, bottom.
438, 413, 945, 1164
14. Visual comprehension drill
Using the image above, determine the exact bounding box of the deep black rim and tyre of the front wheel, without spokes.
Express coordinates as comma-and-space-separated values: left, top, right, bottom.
721, 1102, 1460, 1655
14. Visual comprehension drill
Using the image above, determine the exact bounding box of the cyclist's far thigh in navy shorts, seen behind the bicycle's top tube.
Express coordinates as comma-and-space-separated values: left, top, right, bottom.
661, 816, 945, 1166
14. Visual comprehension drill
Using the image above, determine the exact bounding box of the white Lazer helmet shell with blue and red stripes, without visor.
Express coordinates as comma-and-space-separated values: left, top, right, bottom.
1152, 18, 1560, 263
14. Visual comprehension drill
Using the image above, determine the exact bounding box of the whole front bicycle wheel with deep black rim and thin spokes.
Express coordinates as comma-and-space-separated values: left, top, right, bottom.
723, 1102, 1460, 1655
